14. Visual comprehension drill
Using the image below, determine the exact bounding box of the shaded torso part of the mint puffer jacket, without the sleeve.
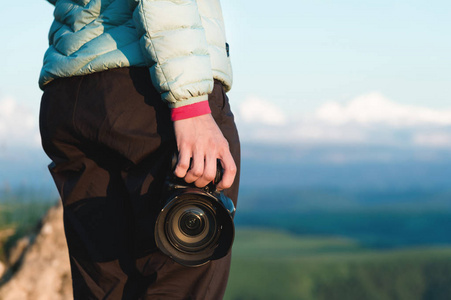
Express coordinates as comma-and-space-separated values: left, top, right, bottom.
39, 0, 146, 88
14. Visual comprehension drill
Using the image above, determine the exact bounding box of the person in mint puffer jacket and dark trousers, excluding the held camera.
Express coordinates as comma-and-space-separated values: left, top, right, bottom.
39, 0, 240, 300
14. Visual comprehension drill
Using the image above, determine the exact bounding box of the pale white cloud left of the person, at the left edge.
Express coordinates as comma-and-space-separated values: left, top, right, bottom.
0, 97, 40, 152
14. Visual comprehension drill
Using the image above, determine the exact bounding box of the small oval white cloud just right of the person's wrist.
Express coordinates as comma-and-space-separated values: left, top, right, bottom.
239, 97, 287, 126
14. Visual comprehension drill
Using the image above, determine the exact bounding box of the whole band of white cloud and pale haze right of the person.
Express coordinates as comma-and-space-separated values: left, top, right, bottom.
237, 93, 451, 148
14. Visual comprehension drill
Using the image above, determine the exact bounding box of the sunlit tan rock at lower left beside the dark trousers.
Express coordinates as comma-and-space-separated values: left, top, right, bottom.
0, 206, 73, 300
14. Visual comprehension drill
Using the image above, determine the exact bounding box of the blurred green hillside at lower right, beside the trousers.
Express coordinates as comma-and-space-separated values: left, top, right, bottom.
225, 228, 451, 300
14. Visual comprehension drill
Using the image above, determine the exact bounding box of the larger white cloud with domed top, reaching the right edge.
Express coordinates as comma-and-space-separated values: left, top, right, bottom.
316, 93, 451, 127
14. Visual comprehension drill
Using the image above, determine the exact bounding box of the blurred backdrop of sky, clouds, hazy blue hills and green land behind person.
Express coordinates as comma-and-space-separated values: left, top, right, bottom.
0, 0, 451, 300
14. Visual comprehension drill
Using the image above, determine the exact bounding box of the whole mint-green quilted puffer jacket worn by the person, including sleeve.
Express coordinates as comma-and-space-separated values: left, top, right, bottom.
39, 0, 232, 108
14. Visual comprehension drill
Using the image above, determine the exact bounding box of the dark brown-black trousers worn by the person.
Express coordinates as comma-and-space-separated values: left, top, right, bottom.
40, 68, 240, 300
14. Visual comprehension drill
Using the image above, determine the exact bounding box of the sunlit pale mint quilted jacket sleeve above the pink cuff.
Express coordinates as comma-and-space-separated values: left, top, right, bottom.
133, 0, 213, 108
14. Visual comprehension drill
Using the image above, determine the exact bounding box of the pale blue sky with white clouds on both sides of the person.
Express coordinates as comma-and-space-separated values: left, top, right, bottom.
0, 0, 451, 154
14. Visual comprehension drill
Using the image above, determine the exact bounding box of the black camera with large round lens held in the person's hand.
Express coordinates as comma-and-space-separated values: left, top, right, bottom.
155, 155, 235, 267
